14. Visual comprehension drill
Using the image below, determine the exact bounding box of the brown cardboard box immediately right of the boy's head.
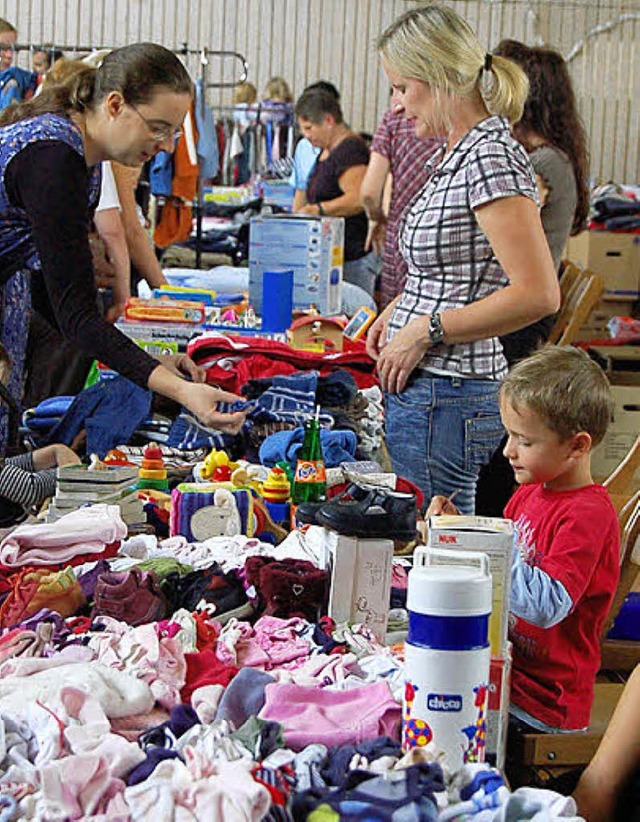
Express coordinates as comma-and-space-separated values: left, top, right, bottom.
591, 385, 640, 487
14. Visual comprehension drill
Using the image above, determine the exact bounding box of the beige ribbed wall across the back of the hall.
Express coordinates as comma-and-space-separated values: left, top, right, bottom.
0, 0, 640, 183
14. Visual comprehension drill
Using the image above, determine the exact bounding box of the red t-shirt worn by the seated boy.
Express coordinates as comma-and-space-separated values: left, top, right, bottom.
504, 485, 620, 729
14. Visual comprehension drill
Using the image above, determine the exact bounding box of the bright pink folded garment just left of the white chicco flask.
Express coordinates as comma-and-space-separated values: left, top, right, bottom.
258, 682, 400, 751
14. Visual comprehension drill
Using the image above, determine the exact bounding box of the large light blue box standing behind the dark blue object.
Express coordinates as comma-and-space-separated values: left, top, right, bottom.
249, 214, 344, 316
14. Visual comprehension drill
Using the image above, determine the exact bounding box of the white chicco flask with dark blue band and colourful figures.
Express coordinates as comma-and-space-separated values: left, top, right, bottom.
402, 548, 492, 771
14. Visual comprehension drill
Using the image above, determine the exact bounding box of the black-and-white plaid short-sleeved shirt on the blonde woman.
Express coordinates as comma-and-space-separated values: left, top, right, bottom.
389, 116, 538, 380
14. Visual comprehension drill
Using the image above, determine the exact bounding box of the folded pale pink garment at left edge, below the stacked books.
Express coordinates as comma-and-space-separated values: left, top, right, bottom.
0, 504, 127, 568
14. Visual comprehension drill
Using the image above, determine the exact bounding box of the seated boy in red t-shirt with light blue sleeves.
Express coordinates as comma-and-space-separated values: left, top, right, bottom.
430, 346, 620, 732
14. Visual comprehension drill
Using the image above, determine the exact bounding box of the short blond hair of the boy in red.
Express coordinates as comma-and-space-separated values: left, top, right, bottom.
500, 345, 613, 445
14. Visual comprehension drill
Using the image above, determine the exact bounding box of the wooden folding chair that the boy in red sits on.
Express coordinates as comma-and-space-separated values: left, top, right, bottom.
508, 492, 640, 787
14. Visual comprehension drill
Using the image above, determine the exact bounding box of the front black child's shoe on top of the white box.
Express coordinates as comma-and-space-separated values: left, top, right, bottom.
316, 484, 417, 541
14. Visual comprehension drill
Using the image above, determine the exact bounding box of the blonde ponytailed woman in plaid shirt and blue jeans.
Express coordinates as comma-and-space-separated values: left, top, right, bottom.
367, 4, 560, 514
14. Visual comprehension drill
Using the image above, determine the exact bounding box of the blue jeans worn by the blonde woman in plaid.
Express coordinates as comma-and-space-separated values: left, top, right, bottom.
386, 372, 504, 514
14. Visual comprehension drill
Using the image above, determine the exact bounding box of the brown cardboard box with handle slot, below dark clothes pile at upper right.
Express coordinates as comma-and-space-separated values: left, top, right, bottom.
565, 231, 640, 300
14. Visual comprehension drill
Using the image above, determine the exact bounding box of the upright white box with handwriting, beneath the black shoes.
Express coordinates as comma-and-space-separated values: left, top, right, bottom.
328, 534, 393, 642
